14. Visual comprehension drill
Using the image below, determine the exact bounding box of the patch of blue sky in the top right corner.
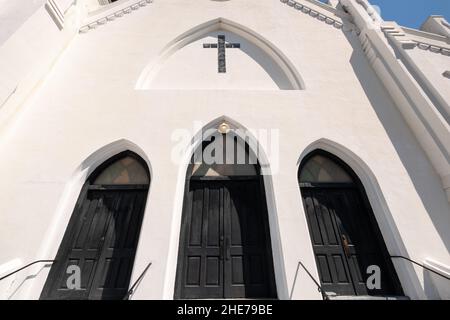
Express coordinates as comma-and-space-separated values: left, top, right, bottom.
369, 0, 450, 28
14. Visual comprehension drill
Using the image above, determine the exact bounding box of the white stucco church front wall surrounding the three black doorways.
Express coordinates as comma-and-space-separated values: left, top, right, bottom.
0, 0, 450, 299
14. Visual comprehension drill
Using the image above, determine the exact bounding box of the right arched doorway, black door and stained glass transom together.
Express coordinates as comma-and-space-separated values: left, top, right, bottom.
298, 150, 403, 296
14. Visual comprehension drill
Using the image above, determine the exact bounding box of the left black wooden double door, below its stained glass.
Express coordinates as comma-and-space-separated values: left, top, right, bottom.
41, 186, 148, 299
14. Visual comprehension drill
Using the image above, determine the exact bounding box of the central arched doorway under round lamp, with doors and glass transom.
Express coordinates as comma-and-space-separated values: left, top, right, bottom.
174, 127, 277, 299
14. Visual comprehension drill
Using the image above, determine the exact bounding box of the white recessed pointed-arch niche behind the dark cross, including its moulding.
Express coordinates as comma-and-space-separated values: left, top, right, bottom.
135, 18, 305, 90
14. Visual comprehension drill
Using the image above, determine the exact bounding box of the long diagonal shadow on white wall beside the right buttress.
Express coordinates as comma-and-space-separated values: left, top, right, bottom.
345, 30, 450, 297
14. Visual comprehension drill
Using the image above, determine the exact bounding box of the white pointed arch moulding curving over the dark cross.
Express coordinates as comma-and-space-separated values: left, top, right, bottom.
135, 17, 305, 90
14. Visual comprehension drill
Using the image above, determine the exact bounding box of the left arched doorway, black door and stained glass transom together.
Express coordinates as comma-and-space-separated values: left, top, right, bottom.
41, 151, 150, 300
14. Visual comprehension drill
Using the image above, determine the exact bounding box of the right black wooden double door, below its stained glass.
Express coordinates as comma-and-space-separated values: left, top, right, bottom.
301, 184, 401, 295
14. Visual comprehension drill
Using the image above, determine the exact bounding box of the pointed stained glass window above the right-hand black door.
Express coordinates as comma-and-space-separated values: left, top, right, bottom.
300, 155, 353, 183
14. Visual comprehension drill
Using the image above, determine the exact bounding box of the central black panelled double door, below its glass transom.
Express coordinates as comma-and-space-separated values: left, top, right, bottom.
175, 176, 276, 299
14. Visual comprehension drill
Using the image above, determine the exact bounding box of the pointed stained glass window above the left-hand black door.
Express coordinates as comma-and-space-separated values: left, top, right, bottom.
94, 156, 149, 185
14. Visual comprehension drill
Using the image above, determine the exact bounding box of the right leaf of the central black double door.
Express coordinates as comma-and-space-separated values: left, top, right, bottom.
224, 180, 273, 298
